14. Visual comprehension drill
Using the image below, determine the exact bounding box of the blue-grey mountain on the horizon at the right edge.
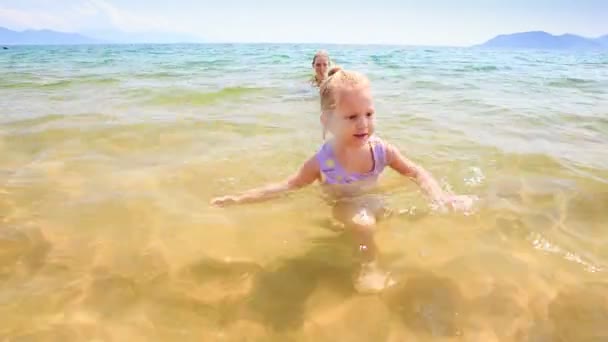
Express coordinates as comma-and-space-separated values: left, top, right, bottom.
478, 31, 607, 50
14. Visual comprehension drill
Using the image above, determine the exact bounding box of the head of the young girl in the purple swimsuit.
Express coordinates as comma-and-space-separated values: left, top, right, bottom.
320, 67, 375, 145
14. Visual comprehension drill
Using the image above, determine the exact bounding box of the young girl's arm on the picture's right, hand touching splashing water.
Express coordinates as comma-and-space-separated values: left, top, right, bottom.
386, 144, 473, 210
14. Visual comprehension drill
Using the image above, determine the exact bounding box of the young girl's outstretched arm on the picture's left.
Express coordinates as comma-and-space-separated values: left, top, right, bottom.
211, 156, 320, 206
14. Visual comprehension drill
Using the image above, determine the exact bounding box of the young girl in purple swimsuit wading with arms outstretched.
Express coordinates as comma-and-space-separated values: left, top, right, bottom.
211, 68, 472, 292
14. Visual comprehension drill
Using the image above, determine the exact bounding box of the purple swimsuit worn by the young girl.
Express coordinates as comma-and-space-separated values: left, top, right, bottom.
317, 136, 387, 185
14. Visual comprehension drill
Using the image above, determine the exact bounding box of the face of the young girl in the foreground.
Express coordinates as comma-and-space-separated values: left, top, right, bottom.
324, 87, 375, 146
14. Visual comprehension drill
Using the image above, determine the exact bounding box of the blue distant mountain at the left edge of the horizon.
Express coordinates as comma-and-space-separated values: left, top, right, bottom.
0, 27, 103, 45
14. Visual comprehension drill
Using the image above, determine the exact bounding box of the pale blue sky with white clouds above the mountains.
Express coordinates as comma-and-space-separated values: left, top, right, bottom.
0, 0, 608, 45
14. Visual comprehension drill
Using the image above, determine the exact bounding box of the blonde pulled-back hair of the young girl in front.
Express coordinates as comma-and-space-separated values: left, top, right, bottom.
319, 67, 369, 140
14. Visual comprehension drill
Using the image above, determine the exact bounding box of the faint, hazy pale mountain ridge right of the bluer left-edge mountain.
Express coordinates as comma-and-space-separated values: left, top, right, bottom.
84, 30, 204, 44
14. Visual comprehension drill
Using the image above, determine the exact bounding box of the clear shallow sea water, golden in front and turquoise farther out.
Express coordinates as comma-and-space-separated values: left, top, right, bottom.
0, 44, 608, 341
